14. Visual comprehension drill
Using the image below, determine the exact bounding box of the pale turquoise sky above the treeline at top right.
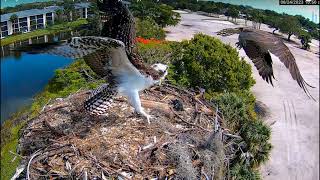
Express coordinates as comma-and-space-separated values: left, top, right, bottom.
212, 0, 319, 23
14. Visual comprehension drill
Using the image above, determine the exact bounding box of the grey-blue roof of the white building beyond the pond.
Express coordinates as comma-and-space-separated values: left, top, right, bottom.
0, 2, 90, 22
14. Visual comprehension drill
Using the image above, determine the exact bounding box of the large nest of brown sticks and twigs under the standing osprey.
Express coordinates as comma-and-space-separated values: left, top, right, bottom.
19, 84, 235, 179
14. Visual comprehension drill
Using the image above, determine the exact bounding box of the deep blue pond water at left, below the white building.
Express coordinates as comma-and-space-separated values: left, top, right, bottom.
1, 32, 73, 123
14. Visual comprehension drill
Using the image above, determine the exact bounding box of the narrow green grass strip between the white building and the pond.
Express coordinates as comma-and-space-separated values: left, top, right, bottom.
0, 19, 88, 46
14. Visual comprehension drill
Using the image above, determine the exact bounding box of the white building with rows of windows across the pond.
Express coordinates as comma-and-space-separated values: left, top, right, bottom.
0, 3, 90, 39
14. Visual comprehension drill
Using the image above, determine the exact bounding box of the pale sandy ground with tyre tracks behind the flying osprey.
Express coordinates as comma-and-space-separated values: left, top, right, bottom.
166, 12, 319, 180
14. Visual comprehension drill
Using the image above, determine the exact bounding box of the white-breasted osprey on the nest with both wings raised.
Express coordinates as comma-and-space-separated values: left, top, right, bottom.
17, 0, 168, 122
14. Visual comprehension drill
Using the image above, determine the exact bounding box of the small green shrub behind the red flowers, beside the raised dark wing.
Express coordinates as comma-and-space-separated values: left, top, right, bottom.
136, 18, 166, 40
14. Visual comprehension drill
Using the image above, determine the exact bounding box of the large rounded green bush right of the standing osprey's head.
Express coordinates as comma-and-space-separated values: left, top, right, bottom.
169, 34, 255, 93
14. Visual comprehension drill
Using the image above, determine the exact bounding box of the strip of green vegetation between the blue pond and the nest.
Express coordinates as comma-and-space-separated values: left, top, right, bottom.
0, 59, 103, 180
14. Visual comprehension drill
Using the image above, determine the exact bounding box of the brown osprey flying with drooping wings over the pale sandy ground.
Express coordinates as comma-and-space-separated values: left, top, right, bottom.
217, 27, 314, 99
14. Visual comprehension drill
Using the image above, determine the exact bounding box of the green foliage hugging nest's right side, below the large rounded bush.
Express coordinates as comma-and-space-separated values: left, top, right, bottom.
214, 92, 272, 168
